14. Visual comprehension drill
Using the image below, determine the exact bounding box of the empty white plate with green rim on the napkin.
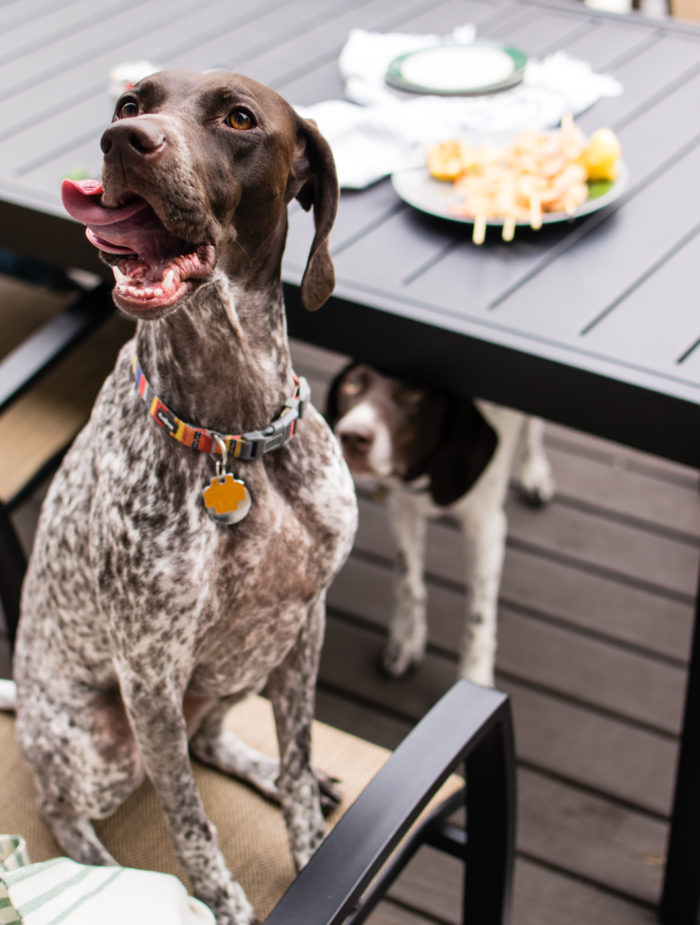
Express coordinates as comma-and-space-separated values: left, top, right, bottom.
386, 41, 527, 96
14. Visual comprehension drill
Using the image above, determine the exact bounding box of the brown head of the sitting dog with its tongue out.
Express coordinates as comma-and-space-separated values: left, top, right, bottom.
63, 70, 338, 318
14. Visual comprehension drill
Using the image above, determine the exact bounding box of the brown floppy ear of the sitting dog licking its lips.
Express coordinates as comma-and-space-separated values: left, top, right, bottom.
292, 118, 338, 311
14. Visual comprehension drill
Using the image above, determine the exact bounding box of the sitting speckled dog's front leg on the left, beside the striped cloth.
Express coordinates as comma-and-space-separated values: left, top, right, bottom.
118, 663, 256, 925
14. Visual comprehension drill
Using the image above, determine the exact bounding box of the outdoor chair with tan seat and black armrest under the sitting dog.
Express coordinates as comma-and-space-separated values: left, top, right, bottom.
0, 681, 515, 925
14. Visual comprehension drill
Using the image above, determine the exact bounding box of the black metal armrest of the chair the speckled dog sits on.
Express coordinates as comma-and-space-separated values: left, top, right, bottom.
265, 680, 515, 925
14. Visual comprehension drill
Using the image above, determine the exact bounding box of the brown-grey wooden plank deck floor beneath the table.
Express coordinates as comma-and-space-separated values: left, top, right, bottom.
0, 276, 700, 925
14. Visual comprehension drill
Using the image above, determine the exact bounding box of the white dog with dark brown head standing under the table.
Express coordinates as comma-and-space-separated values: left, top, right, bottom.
326, 363, 554, 685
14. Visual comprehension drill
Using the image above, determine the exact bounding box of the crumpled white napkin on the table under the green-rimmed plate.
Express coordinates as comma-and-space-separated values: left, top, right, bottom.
297, 25, 622, 189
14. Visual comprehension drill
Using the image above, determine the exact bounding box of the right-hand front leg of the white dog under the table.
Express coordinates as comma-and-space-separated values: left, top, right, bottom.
459, 506, 507, 686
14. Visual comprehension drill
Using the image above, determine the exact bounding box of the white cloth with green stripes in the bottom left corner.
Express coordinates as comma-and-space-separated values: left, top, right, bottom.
0, 835, 215, 925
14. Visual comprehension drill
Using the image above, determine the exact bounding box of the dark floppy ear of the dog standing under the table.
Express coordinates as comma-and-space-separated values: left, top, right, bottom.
428, 397, 498, 507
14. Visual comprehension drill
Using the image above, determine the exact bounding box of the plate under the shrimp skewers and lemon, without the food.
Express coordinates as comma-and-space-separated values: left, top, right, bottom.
391, 164, 627, 227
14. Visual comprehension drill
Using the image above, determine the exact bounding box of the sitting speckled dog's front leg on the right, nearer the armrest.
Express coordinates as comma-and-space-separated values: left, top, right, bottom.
267, 592, 326, 870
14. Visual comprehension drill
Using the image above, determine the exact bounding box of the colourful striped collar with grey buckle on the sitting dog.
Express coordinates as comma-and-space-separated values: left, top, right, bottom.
133, 354, 311, 460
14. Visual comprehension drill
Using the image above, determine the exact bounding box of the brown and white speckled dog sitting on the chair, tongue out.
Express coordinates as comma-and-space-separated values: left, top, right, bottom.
15, 71, 356, 925
